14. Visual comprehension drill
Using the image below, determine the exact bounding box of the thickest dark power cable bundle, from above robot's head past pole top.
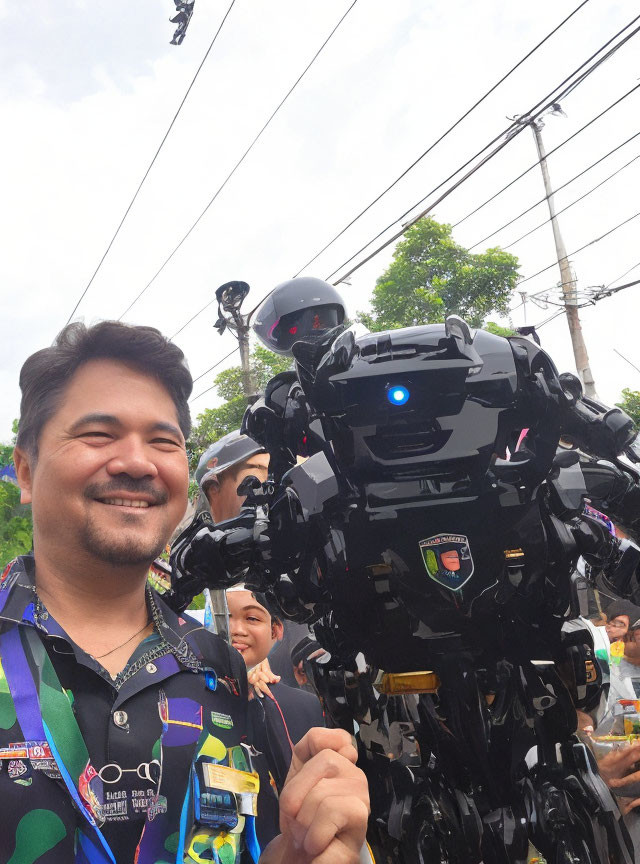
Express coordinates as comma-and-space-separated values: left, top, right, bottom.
326, 15, 640, 285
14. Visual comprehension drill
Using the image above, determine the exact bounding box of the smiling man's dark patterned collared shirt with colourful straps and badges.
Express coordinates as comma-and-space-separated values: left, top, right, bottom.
0, 556, 259, 864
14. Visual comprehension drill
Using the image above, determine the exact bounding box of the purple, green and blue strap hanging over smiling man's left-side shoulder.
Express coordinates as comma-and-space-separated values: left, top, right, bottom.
0, 627, 116, 864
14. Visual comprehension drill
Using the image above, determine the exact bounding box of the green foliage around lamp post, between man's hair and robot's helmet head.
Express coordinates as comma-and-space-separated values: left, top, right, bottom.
188, 345, 292, 471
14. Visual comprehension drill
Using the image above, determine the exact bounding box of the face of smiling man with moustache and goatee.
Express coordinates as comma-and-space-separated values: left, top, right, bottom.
16, 360, 189, 567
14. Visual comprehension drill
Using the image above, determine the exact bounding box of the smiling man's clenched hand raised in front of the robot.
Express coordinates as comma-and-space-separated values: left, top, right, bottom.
260, 729, 369, 864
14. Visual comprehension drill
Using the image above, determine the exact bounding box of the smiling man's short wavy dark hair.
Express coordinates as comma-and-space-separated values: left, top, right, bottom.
16, 321, 193, 456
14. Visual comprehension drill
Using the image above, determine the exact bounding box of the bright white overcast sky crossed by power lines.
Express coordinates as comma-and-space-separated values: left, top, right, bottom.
0, 0, 640, 440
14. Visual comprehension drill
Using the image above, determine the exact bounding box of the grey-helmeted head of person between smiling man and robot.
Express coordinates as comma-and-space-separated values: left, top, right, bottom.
196, 429, 269, 523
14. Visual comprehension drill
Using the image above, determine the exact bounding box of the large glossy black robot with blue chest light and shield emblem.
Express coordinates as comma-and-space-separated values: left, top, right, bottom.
172, 278, 640, 864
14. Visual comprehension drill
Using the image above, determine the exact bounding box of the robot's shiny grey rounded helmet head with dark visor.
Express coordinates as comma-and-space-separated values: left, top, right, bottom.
253, 276, 345, 355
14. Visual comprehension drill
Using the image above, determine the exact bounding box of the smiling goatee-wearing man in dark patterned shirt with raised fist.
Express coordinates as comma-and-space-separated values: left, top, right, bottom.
0, 322, 367, 864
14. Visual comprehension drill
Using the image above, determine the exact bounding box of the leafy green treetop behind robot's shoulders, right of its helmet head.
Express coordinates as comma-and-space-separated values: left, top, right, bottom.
359, 217, 518, 331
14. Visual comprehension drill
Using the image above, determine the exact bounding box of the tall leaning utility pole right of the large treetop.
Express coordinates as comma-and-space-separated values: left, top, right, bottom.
528, 116, 596, 397
